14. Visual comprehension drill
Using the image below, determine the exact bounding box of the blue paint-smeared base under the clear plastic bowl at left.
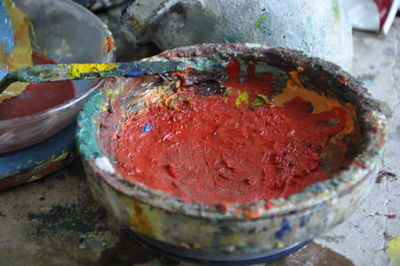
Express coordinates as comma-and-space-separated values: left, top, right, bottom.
0, 122, 76, 190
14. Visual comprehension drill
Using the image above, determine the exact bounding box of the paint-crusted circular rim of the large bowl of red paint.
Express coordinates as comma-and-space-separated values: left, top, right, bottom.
77, 44, 386, 220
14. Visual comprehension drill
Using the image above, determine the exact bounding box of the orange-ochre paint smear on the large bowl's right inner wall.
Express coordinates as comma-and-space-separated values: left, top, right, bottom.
272, 71, 356, 134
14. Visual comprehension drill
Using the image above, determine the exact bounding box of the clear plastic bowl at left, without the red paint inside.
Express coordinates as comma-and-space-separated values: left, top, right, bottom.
0, 0, 114, 153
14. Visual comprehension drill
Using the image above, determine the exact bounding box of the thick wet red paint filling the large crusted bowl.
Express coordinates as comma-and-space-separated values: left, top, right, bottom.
101, 60, 359, 203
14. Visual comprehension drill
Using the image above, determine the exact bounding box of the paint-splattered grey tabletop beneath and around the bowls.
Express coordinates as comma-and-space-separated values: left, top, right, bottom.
0, 7, 400, 265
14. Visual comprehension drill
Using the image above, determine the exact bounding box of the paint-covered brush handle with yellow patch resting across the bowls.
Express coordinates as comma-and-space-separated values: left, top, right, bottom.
0, 61, 193, 93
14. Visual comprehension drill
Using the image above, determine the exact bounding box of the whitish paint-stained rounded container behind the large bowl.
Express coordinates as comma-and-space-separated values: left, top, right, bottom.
123, 0, 353, 69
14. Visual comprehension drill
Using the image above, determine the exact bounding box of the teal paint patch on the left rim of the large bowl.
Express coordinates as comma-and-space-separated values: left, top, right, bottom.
76, 91, 104, 160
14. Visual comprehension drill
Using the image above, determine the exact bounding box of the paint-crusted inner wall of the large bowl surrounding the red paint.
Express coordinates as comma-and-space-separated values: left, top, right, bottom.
85, 44, 382, 214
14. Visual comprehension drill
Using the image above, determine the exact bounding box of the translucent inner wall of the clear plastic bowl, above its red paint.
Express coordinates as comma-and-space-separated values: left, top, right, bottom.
14, 0, 113, 97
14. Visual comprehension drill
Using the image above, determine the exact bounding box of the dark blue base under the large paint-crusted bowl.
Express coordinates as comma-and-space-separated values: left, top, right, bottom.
125, 228, 311, 265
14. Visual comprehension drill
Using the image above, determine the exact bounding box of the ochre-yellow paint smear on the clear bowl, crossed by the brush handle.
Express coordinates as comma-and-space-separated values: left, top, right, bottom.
0, 0, 33, 103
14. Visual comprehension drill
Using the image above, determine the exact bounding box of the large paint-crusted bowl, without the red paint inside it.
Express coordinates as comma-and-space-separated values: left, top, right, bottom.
77, 44, 385, 264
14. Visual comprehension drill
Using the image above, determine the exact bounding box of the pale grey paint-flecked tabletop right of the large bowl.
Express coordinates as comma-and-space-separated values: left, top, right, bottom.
316, 18, 400, 266
